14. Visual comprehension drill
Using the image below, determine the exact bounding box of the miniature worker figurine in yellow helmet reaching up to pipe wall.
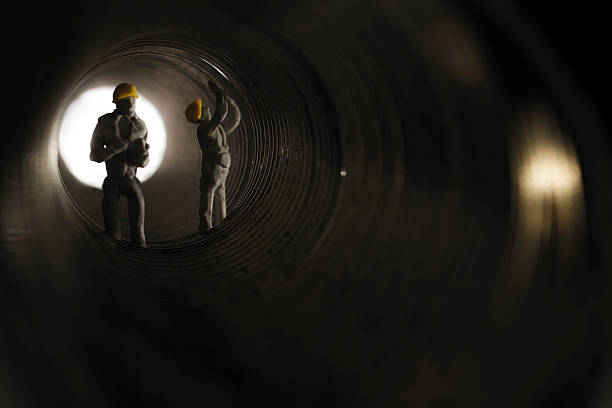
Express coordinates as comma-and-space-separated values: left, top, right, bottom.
185, 81, 241, 234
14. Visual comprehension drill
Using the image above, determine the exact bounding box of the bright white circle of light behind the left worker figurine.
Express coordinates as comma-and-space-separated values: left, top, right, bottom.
59, 87, 166, 189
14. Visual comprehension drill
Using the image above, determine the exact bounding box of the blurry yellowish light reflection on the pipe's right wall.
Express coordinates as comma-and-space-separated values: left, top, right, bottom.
510, 106, 585, 287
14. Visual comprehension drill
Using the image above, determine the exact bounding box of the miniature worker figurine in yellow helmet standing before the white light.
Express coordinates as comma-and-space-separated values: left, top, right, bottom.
89, 83, 149, 248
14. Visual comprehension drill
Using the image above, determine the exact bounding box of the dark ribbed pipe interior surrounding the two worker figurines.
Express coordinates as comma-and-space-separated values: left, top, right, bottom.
0, 0, 612, 408
